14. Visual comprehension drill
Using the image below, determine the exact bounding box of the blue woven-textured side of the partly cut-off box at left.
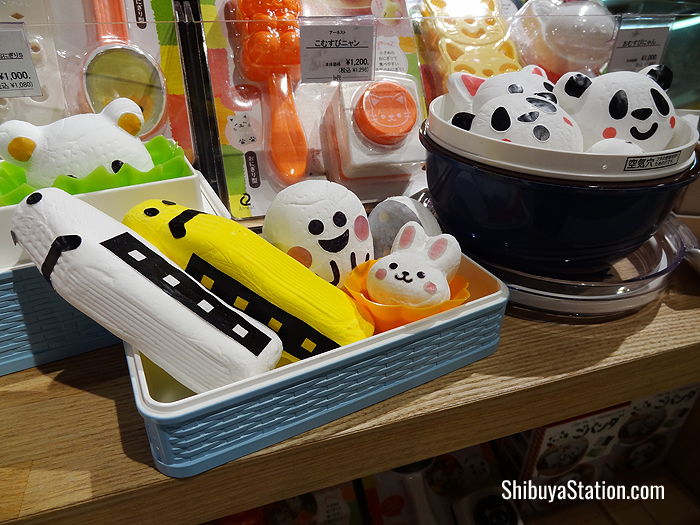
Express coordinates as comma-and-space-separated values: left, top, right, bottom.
0, 266, 119, 375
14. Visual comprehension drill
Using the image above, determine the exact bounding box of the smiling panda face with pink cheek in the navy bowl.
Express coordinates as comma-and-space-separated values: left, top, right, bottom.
554, 67, 676, 152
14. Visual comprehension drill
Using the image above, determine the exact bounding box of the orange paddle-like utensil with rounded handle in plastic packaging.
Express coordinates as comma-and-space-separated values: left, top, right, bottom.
236, 0, 308, 184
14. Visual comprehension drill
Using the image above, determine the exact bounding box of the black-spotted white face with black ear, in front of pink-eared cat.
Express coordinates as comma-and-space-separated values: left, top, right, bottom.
452, 94, 582, 151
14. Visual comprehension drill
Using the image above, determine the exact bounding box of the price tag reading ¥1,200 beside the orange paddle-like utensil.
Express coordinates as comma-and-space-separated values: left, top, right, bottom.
299, 17, 376, 82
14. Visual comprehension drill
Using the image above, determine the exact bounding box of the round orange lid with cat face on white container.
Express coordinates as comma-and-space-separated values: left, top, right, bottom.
353, 80, 418, 145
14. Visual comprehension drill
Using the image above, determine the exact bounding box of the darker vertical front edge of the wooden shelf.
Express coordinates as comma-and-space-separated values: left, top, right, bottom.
9, 338, 700, 523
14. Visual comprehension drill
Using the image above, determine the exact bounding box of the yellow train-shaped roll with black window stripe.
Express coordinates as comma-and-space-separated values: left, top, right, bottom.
124, 200, 374, 361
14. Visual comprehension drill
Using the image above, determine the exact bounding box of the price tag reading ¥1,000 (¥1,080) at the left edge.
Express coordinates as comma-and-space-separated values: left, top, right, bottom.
0, 22, 41, 98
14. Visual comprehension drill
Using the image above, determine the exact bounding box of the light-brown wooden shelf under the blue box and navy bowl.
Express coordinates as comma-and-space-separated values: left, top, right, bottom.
0, 266, 700, 524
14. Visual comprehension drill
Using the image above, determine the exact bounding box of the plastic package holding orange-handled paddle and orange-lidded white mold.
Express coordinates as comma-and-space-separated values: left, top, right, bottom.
201, 0, 426, 220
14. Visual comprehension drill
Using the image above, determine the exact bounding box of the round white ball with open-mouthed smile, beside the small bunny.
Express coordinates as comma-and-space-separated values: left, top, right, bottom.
263, 180, 374, 286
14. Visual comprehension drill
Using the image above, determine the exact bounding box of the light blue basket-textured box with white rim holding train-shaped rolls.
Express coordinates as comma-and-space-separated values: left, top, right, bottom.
126, 261, 508, 477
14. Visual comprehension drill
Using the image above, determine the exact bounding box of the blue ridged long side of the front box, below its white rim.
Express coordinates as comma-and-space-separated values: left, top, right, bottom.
141, 298, 506, 477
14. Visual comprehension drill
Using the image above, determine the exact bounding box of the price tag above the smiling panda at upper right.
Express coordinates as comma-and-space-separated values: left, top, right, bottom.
608, 21, 669, 71
